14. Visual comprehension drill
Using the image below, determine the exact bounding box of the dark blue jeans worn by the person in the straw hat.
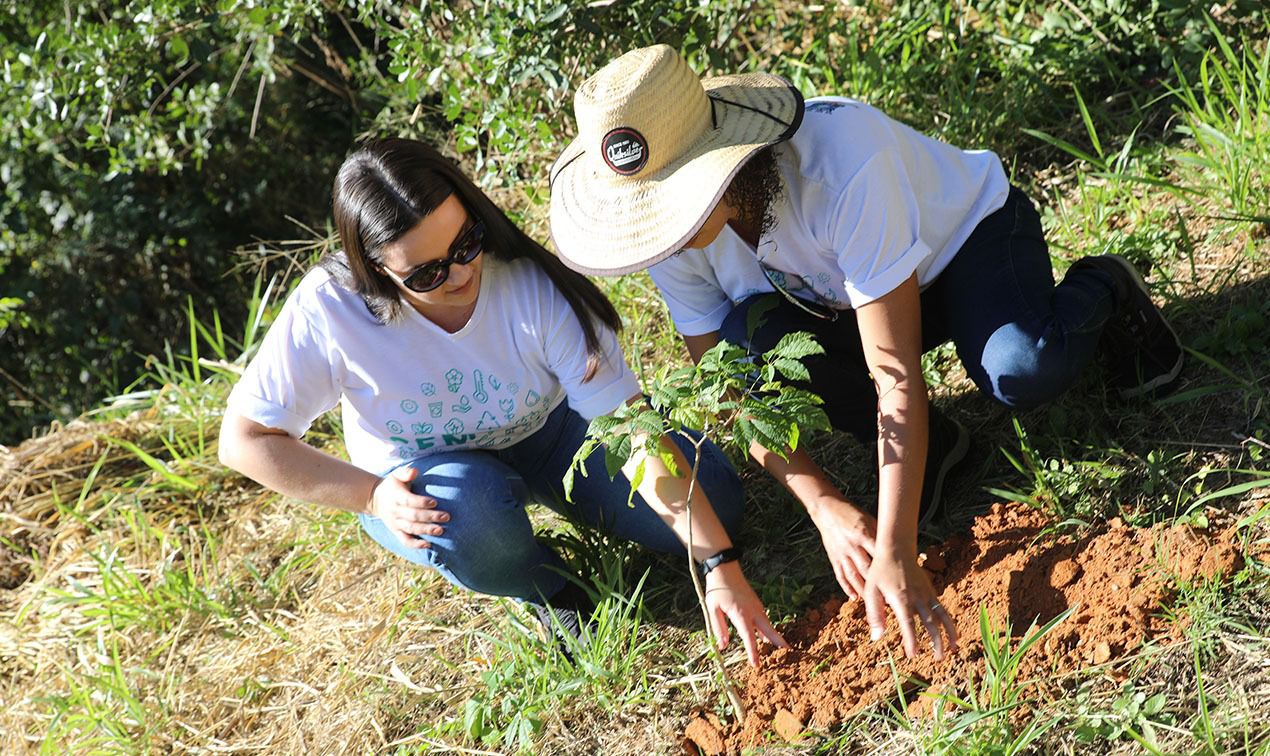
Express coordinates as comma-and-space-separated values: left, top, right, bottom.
720, 187, 1116, 443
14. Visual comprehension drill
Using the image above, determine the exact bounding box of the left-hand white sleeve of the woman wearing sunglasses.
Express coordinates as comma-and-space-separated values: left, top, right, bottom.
229, 290, 340, 438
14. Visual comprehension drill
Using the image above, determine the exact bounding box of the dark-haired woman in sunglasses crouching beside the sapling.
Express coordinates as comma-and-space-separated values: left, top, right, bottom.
220, 140, 782, 663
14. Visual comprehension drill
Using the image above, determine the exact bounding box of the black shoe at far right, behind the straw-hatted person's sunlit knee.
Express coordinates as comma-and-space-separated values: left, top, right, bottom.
1072, 254, 1184, 400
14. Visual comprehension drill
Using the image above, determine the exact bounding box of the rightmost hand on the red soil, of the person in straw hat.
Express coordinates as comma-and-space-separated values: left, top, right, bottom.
865, 549, 956, 661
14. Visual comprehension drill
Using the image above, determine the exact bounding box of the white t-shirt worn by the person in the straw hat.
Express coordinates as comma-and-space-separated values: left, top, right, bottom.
649, 97, 1010, 335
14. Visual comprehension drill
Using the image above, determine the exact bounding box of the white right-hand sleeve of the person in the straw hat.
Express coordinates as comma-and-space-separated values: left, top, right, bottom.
828, 151, 931, 307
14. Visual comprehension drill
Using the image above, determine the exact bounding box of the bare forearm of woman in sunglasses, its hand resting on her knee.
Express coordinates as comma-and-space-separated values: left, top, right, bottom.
220, 417, 380, 512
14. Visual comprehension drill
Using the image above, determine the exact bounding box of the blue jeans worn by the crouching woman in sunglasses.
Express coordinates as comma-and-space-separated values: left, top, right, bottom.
358, 403, 744, 600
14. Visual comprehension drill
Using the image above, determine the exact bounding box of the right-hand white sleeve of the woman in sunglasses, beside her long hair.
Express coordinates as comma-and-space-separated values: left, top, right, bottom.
541, 276, 640, 421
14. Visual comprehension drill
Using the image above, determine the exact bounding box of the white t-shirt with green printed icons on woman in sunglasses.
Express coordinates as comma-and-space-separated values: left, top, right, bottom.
229, 255, 640, 474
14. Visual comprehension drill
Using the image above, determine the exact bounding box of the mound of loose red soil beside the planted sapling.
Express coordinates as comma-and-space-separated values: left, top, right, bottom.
697, 504, 1240, 753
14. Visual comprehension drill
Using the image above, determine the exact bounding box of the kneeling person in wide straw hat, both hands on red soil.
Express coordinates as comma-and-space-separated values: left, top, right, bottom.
551, 46, 1182, 658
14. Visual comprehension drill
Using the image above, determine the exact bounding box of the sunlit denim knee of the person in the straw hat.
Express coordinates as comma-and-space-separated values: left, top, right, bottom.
963, 323, 1081, 410
